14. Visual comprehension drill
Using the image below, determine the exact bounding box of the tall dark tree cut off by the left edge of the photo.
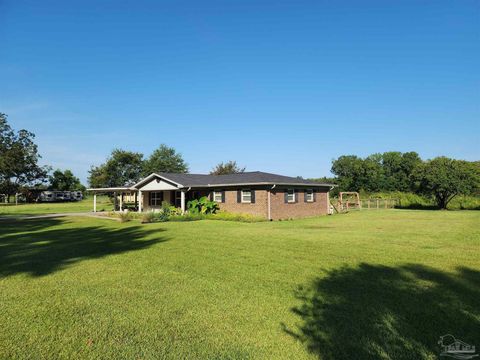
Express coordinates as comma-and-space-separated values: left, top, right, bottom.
0, 113, 50, 201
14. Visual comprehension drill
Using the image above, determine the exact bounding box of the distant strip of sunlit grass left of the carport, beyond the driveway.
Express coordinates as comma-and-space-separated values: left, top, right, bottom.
0, 196, 113, 216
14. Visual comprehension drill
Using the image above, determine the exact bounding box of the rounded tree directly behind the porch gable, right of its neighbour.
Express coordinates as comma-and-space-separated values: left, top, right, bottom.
143, 144, 188, 176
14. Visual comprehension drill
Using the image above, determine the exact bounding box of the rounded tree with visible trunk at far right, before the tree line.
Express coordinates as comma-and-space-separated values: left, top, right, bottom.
413, 156, 480, 209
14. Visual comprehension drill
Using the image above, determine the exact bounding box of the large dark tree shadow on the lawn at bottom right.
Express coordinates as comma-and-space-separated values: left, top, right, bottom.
282, 264, 480, 359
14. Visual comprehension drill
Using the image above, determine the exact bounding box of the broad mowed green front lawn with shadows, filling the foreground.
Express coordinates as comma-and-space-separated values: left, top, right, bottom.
0, 210, 480, 359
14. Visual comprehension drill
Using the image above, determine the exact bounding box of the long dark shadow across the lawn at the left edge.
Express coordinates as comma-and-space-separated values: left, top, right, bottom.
0, 218, 168, 277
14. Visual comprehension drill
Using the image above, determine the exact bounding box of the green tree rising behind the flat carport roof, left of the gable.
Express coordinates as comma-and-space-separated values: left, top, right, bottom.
88, 149, 143, 187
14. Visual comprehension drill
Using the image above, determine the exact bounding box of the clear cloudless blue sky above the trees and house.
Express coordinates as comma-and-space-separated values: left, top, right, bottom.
0, 0, 480, 181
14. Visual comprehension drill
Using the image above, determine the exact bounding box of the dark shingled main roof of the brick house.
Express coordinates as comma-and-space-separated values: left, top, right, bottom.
157, 171, 333, 187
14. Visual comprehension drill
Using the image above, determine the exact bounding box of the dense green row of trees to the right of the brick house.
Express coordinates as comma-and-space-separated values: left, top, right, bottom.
315, 151, 480, 209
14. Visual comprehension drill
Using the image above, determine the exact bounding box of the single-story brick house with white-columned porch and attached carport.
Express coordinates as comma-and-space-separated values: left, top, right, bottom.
89, 171, 333, 220
